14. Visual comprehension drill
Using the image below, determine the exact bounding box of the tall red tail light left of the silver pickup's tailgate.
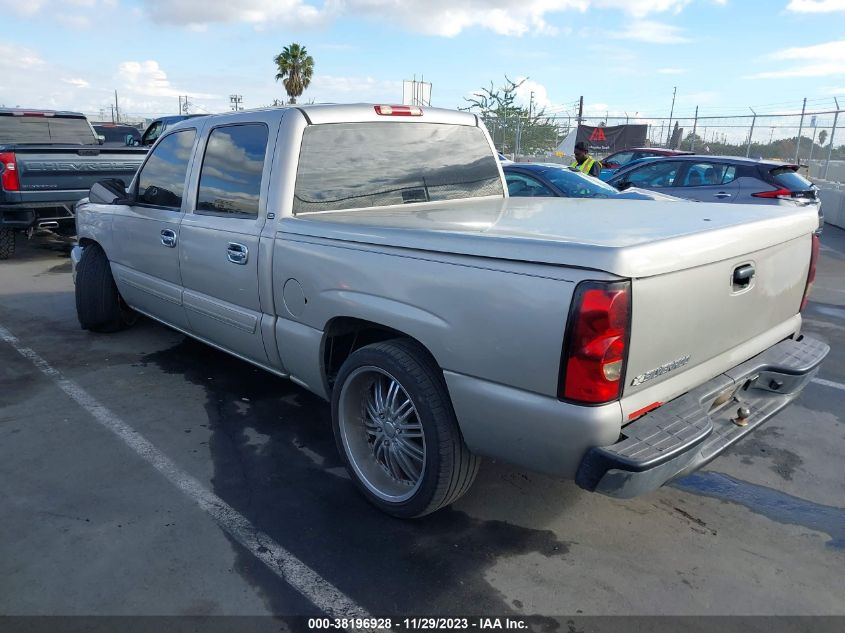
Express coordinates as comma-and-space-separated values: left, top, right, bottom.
558, 281, 631, 404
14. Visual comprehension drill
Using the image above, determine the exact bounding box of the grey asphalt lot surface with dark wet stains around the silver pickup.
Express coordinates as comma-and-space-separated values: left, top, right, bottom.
0, 227, 845, 630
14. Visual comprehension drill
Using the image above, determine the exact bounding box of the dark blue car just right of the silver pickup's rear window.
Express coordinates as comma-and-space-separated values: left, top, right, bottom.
502, 163, 677, 200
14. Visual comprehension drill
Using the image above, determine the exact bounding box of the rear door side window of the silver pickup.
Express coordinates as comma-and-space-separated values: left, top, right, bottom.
196, 123, 269, 218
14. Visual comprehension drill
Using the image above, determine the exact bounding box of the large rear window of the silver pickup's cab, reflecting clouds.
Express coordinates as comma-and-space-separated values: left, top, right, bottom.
293, 122, 504, 213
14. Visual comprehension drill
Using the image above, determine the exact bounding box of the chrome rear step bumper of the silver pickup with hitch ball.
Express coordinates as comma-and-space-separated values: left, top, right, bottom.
575, 337, 830, 498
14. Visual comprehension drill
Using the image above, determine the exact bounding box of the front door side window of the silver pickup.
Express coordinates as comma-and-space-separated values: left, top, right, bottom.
138, 129, 197, 209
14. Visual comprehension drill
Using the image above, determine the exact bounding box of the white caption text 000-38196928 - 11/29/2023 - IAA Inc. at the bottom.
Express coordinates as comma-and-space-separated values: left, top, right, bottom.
308, 617, 528, 631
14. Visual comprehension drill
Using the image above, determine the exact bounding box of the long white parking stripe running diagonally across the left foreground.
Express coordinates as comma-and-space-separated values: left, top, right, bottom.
0, 325, 370, 618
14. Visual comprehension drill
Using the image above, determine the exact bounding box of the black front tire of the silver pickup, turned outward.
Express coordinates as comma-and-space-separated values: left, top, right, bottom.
76, 244, 138, 332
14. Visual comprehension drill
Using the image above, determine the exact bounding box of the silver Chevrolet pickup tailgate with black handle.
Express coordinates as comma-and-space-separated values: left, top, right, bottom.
623, 233, 811, 417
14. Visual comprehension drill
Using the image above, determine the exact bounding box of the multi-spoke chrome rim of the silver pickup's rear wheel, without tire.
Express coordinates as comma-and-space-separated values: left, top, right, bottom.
338, 366, 426, 503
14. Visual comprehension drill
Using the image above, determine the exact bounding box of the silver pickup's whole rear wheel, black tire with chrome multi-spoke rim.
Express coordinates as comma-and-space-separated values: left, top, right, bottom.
332, 339, 480, 519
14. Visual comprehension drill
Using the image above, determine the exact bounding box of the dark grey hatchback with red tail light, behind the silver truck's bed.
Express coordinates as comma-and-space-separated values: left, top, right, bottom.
608, 155, 824, 230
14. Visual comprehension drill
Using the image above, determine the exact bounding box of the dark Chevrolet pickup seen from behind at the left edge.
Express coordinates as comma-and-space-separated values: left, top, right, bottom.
0, 108, 148, 259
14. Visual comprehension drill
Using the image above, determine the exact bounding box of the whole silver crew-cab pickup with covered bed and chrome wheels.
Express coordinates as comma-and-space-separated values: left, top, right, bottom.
73, 105, 828, 517
